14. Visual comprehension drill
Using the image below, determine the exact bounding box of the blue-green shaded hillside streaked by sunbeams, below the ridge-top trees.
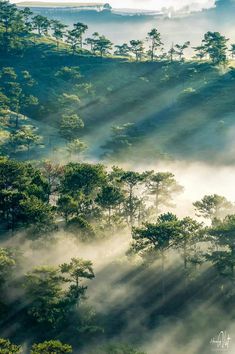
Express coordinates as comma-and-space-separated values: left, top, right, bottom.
0, 42, 235, 163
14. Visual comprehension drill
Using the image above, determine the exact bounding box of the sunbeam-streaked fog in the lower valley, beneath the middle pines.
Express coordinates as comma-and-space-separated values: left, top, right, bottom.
4, 225, 235, 354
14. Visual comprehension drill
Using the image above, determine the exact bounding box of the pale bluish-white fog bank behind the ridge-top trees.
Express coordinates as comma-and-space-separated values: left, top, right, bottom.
22, 0, 234, 47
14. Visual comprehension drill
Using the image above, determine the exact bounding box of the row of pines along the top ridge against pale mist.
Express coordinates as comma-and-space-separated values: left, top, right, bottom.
0, 0, 235, 65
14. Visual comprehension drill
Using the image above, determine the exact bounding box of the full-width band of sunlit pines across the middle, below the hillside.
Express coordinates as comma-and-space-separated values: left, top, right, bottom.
0, 158, 235, 275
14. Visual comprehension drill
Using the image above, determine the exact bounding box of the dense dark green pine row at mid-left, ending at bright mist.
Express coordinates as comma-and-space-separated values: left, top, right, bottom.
0, 157, 182, 232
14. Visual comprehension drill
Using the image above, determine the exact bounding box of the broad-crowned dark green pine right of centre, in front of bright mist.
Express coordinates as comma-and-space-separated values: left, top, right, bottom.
132, 213, 204, 270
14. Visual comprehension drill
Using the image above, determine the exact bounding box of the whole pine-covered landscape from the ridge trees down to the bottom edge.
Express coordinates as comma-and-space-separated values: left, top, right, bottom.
0, 0, 235, 354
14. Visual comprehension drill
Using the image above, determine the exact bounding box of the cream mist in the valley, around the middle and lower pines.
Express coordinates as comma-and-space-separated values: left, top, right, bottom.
1, 156, 235, 354
